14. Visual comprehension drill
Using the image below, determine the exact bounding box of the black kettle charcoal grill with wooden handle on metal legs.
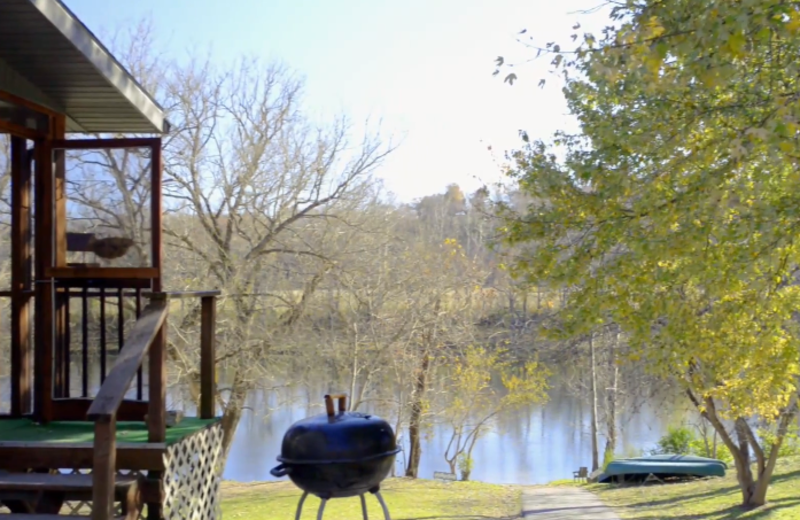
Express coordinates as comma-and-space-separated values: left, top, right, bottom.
270, 394, 400, 520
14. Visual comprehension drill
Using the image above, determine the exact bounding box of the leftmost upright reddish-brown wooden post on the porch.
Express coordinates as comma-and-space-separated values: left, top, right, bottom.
11, 137, 32, 417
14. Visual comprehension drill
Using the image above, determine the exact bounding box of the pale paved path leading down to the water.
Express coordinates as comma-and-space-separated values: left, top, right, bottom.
522, 487, 620, 520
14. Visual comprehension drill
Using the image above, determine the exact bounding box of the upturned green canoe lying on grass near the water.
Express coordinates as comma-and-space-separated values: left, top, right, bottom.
597, 455, 728, 483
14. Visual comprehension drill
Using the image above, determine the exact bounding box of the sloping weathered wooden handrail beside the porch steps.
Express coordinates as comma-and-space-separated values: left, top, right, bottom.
87, 302, 167, 422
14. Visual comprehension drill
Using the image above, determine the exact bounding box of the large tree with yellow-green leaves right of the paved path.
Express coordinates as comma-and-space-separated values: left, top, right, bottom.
501, 0, 800, 507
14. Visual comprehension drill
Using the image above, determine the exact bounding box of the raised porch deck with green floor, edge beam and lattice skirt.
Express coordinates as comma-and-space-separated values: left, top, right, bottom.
0, 417, 222, 519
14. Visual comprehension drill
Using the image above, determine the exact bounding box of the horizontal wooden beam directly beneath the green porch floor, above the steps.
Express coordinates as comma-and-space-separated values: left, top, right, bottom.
0, 441, 167, 474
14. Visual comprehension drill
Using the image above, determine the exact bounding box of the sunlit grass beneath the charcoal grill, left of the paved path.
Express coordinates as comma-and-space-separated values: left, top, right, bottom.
222, 478, 521, 520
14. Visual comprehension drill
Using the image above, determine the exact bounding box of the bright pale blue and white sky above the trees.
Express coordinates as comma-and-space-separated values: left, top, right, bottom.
65, 0, 606, 202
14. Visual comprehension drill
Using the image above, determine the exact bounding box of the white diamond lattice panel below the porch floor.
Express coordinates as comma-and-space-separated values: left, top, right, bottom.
163, 422, 222, 520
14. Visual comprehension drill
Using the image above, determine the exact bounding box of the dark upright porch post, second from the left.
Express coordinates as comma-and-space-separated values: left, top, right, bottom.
33, 139, 54, 422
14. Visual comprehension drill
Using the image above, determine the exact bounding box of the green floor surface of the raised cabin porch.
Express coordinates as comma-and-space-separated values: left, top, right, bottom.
0, 417, 219, 445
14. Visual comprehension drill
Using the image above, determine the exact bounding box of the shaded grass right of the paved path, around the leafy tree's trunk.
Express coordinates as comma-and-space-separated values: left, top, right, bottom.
556, 458, 800, 520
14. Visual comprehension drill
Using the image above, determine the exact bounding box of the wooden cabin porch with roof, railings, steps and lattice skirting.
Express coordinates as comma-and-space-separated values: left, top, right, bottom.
0, 0, 222, 520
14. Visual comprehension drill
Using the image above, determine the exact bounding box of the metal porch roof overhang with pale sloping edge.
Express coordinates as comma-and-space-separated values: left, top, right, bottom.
0, 0, 169, 133
